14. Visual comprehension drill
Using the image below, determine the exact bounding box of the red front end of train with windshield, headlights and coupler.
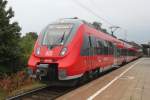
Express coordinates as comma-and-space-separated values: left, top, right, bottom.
28, 19, 82, 81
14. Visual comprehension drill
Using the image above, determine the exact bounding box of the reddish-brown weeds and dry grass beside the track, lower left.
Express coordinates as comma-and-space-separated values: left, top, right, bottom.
0, 71, 46, 100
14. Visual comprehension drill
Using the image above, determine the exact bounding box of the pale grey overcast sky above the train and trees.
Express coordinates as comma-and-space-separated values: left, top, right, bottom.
8, 0, 150, 43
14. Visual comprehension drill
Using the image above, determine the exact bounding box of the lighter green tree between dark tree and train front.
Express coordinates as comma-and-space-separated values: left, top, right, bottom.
19, 32, 38, 67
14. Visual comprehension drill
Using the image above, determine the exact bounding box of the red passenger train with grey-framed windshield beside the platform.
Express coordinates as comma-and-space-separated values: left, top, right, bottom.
28, 19, 140, 84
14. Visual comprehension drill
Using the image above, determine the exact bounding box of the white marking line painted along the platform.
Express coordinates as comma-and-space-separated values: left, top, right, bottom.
87, 59, 144, 100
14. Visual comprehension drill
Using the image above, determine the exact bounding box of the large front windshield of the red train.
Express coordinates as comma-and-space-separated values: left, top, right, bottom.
41, 24, 73, 46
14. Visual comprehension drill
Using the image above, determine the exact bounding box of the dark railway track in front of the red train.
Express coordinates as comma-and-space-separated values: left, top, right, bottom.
6, 86, 73, 100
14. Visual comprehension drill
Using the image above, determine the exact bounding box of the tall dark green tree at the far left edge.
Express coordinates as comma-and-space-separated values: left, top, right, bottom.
0, 0, 21, 72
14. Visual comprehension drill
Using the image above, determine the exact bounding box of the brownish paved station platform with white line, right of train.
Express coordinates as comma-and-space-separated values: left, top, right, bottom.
57, 58, 150, 100
